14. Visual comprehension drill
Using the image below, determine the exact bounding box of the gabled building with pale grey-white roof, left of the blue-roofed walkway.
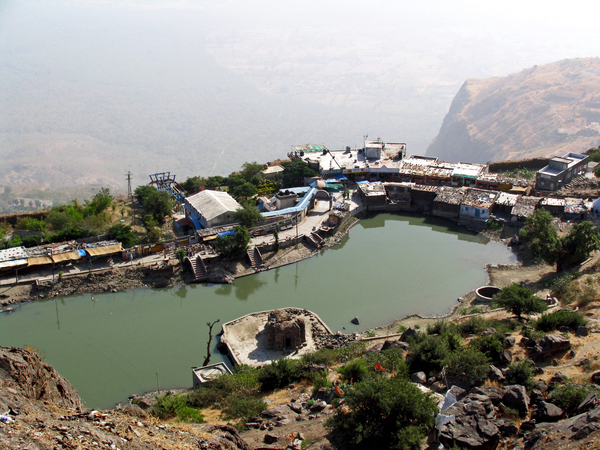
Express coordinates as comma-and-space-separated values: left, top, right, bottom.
184, 190, 242, 230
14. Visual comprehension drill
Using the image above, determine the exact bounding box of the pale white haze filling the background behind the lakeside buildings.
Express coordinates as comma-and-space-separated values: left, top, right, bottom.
0, 0, 600, 199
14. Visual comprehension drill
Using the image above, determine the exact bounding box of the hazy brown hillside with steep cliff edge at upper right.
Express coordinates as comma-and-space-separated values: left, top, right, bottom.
427, 58, 600, 163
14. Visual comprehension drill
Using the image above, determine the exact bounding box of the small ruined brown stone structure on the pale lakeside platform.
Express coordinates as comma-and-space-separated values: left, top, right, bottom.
265, 309, 306, 351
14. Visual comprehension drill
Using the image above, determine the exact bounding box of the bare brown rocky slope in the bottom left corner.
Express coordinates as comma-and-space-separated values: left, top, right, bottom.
0, 347, 250, 450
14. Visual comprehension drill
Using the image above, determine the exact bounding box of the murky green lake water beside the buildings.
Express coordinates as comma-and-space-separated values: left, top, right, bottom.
0, 214, 514, 409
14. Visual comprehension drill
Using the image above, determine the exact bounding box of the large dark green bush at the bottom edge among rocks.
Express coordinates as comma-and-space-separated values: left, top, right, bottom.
327, 377, 437, 450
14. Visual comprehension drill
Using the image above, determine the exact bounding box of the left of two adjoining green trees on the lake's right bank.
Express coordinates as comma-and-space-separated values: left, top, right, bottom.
519, 209, 561, 264
